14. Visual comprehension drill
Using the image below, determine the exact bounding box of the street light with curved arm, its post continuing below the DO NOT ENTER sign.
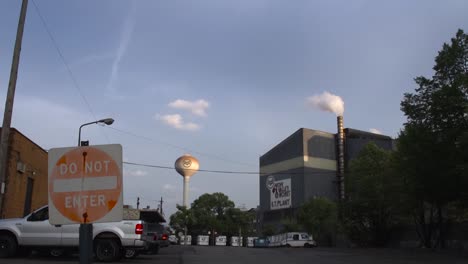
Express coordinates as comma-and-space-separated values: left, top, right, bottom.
78, 118, 114, 264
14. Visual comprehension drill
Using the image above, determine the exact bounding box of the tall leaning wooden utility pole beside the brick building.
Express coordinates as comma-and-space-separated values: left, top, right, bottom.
0, 0, 28, 217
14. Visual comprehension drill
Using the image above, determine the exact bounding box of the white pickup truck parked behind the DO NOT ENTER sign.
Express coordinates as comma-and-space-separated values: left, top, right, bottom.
0, 206, 159, 262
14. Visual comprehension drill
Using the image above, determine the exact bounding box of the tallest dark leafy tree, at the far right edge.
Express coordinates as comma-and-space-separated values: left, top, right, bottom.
397, 30, 468, 248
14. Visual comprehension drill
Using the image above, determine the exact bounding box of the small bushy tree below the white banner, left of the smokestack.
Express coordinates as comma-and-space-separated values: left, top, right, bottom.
297, 198, 338, 245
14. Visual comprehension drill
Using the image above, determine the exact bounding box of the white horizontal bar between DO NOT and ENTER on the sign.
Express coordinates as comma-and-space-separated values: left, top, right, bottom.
54, 176, 117, 193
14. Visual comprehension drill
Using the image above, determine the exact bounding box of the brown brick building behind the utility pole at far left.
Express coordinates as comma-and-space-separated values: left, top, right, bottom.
0, 128, 48, 218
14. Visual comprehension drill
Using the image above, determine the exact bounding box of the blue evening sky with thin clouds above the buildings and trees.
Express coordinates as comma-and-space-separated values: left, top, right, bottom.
0, 0, 468, 218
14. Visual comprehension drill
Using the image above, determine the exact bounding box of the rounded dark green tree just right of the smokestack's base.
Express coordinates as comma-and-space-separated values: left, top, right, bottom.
342, 143, 401, 246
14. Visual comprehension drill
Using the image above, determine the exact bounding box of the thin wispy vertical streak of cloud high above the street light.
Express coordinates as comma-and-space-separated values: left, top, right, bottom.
106, 4, 135, 91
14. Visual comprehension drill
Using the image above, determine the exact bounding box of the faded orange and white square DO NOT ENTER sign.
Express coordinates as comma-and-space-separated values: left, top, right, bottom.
49, 144, 123, 225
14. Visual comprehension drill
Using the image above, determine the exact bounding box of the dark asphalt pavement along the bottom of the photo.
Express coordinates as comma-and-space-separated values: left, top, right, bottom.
0, 246, 468, 264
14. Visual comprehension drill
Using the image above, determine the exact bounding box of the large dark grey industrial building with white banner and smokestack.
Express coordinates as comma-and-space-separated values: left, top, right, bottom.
259, 117, 393, 227
